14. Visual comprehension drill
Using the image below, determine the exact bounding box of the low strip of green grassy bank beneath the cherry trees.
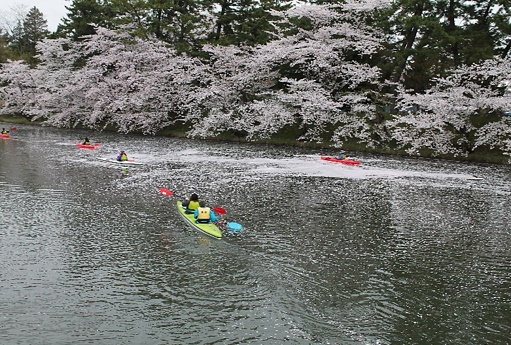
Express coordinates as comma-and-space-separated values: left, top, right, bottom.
0, 115, 510, 165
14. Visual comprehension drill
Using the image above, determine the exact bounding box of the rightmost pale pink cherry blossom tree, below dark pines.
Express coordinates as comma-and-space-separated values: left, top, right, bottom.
387, 58, 511, 156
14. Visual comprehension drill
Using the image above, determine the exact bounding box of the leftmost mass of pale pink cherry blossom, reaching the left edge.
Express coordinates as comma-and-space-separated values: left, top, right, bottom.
0, 28, 206, 133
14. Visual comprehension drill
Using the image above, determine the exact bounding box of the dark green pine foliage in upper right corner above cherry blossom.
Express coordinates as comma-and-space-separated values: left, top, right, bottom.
375, 0, 511, 92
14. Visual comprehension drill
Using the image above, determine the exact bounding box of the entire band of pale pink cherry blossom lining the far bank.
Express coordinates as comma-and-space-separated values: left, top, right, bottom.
0, 0, 511, 155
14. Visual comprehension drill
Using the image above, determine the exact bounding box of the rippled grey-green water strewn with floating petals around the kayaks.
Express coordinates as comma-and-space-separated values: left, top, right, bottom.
0, 124, 511, 345
